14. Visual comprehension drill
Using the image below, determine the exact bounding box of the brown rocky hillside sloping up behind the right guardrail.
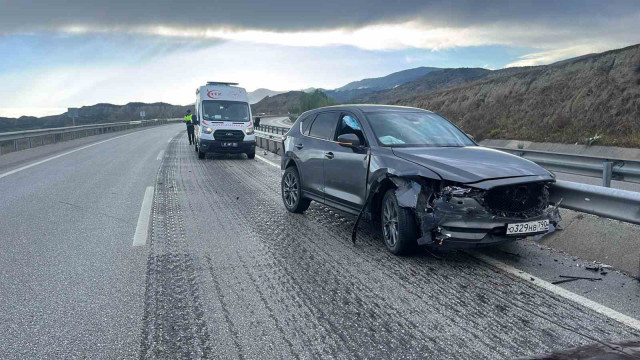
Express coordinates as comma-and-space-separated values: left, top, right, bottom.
376, 45, 640, 147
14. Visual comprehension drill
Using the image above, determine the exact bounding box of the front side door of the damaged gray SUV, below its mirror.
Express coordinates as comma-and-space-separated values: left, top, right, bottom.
324, 112, 368, 211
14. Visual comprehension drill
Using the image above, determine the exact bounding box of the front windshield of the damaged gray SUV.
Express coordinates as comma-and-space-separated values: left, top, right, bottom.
367, 111, 475, 147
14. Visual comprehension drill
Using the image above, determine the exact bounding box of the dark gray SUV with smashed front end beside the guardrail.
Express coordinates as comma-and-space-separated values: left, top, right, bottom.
281, 105, 560, 254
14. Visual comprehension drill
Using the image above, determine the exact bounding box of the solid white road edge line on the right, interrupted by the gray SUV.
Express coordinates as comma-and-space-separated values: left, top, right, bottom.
256, 150, 640, 330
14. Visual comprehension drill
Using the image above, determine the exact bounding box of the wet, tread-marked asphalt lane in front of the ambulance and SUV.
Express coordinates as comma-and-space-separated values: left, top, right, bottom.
141, 136, 640, 359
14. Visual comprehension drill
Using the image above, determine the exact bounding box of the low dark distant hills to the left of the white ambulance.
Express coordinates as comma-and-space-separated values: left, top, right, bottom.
0, 103, 193, 132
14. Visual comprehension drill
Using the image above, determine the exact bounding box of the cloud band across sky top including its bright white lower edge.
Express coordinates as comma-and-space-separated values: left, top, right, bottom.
5, 0, 640, 50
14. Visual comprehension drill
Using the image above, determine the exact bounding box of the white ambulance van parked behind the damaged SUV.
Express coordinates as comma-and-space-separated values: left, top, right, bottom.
193, 82, 256, 159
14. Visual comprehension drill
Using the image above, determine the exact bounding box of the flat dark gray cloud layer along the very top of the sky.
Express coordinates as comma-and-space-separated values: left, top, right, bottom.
0, 0, 638, 32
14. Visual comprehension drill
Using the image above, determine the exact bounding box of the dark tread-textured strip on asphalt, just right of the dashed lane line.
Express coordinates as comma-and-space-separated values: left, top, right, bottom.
139, 142, 212, 359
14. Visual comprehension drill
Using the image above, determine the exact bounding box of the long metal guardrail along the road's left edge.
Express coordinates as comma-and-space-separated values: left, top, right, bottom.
0, 118, 180, 155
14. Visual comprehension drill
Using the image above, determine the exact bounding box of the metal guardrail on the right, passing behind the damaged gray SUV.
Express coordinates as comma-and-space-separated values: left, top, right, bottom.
256, 126, 640, 225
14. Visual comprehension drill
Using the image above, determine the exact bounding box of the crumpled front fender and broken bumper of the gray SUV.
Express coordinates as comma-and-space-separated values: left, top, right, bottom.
360, 148, 561, 248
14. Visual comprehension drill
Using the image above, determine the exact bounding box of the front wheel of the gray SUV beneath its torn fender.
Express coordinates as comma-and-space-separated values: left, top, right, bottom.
380, 188, 418, 255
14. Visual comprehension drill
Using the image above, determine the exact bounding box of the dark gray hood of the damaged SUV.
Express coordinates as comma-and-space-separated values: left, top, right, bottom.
392, 146, 550, 184
